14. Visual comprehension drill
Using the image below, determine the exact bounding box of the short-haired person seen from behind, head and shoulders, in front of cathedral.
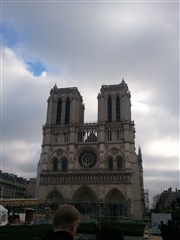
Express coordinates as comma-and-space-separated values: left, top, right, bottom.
43, 204, 80, 240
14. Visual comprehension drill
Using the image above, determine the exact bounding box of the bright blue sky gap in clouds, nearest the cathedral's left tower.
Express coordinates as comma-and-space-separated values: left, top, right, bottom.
26, 59, 46, 77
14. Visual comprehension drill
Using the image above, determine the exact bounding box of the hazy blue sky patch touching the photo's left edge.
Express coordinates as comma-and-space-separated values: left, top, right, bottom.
1, 24, 18, 48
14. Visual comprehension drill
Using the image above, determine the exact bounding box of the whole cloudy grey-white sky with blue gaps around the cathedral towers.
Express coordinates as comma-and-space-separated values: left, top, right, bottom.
1, 0, 180, 206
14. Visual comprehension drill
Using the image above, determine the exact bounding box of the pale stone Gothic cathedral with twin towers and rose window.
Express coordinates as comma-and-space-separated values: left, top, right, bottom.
36, 80, 144, 219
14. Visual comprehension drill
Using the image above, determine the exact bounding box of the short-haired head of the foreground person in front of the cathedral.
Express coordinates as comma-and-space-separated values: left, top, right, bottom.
53, 204, 80, 236
